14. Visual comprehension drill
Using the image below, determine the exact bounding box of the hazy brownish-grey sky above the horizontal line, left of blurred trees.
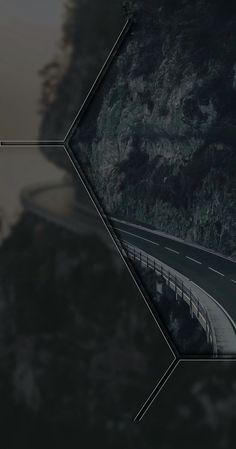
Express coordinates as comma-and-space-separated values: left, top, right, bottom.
0, 0, 66, 140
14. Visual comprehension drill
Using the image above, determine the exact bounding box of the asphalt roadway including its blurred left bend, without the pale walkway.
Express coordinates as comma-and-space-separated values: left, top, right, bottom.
22, 184, 236, 332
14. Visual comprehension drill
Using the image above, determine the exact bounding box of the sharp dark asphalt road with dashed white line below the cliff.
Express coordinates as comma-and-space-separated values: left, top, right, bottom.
112, 219, 236, 323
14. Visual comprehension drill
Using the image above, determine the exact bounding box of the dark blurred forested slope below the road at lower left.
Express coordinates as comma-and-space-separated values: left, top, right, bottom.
0, 211, 173, 449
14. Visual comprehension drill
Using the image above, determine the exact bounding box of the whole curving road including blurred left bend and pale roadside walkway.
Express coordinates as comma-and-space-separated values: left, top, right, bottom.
21, 182, 236, 357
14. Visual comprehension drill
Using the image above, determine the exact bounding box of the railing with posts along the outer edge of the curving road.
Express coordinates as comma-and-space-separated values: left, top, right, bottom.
123, 242, 217, 354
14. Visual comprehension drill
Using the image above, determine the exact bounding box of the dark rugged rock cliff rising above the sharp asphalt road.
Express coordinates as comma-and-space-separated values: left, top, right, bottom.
72, 0, 236, 257
